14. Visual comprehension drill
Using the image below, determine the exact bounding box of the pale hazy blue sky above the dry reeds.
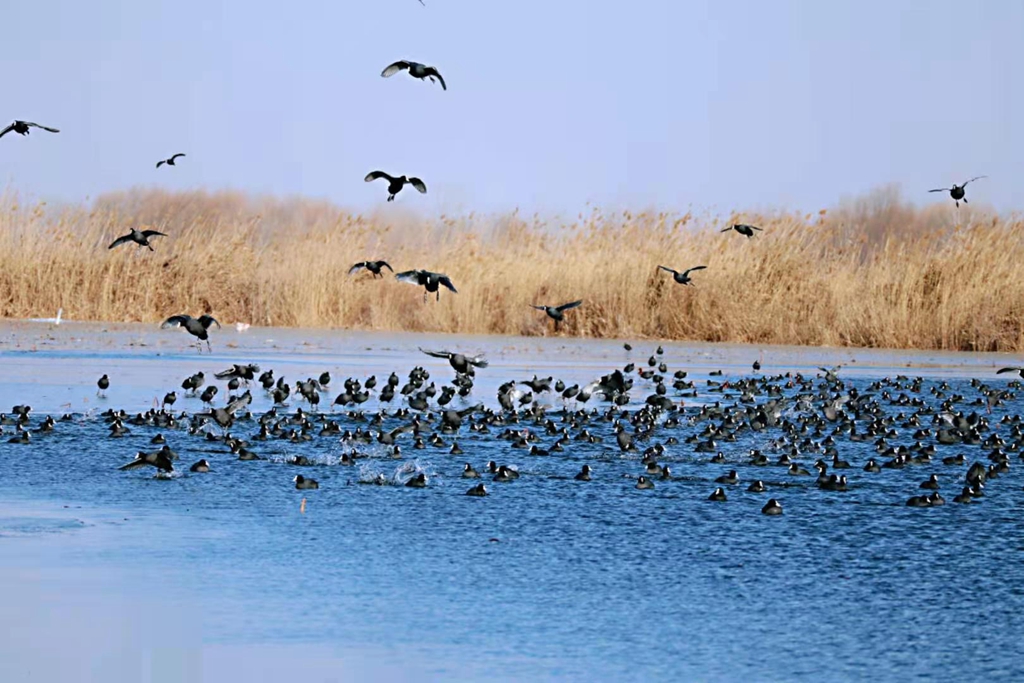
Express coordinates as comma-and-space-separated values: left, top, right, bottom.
0, 0, 1024, 213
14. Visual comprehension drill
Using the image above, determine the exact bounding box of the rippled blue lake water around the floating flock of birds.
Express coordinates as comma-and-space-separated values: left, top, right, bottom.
0, 324, 1024, 681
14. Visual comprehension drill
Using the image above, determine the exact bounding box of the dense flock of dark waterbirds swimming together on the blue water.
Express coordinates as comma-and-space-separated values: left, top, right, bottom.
0, 342, 1024, 515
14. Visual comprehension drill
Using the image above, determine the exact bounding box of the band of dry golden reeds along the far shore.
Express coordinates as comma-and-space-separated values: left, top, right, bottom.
0, 185, 1024, 350
